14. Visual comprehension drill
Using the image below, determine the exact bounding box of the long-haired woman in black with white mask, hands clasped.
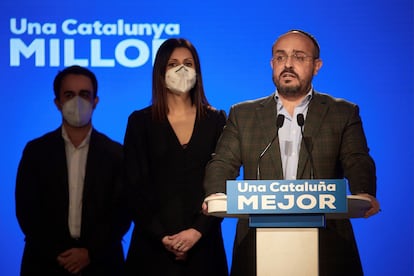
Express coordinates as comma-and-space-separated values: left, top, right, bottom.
124, 38, 228, 276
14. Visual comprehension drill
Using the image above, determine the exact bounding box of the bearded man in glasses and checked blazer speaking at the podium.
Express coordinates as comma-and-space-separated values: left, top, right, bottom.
203, 30, 379, 276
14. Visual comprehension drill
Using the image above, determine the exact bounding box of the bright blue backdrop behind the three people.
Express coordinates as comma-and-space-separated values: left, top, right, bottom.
0, 0, 414, 276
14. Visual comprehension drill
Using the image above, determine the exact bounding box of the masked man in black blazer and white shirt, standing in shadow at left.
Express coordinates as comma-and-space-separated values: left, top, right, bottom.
15, 66, 129, 276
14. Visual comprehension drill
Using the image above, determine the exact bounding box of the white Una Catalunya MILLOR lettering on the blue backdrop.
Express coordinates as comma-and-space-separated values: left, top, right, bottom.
9, 18, 180, 67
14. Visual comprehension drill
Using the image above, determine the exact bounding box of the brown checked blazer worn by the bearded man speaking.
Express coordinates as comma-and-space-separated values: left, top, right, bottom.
204, 91, 376, 275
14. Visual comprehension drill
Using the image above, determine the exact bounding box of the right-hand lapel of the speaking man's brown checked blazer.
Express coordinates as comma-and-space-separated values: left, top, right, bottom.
296, 91, 328, 179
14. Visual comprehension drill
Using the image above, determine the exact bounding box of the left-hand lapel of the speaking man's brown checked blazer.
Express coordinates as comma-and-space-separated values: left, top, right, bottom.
256, 94, 283, 179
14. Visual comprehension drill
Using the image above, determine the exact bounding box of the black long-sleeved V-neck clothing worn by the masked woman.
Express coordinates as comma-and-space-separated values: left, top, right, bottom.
124, 107, 228, 276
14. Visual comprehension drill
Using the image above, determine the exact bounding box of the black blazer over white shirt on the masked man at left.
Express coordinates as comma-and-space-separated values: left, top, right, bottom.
15, 128, 129, 275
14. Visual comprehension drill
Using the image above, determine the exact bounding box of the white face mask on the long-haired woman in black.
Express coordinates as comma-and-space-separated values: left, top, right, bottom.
165, 65, 197, 93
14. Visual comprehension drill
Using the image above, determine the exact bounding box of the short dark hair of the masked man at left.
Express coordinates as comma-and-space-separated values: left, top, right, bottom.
53, 65, 98, 100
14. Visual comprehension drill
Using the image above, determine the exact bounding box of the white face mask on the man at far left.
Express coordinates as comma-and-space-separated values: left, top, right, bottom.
62, 96, 93, 127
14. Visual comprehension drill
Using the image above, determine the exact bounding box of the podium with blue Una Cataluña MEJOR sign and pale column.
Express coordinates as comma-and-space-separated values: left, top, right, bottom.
205, 179, 371, 276
